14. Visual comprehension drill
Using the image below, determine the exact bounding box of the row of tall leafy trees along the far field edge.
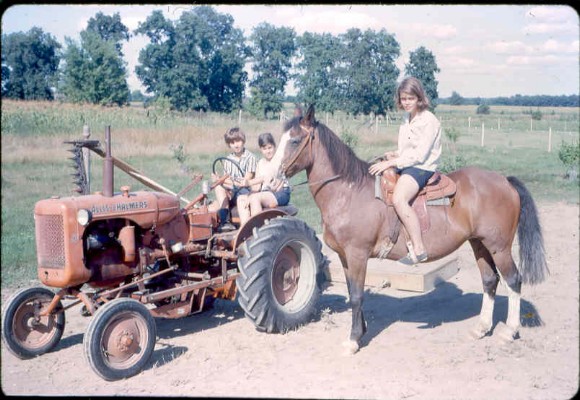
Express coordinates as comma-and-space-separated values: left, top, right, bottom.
7, 6, 577, 118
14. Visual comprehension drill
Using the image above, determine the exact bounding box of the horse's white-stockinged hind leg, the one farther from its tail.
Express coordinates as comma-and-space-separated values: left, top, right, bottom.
469, 239, 499, 339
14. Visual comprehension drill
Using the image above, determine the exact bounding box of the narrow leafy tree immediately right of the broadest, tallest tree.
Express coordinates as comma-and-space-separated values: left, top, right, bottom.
250, 22, 296, 118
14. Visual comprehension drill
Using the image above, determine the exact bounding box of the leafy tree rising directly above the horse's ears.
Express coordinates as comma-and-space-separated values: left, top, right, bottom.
295, 32, 342, 113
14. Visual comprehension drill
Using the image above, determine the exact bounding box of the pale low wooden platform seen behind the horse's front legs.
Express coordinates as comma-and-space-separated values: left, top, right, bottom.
320, 238, 459, 292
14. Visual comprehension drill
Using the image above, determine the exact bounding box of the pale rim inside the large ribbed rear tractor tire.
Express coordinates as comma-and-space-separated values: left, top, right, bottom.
271, 241, 316, 312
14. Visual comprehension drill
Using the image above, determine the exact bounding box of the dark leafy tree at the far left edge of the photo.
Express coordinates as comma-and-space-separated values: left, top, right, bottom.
2, 27, 61, 100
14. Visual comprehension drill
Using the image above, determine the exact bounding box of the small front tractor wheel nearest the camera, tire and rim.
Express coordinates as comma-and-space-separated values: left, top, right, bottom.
84, 298, 156, 381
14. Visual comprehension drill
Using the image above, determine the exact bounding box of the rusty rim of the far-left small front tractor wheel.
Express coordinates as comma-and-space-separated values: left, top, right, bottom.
12, 297, 58, 351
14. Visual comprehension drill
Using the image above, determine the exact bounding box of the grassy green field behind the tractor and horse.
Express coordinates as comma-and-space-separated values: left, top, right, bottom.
1, 101, 580, 288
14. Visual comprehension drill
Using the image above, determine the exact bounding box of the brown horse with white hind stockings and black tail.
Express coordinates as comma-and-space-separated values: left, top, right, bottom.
282, 106, 549, 353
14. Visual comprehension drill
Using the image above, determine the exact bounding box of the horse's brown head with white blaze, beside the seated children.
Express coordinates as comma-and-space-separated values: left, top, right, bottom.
281, 104, 318, 178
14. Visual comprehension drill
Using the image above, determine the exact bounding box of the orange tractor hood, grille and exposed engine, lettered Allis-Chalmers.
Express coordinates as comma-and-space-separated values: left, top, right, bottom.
34, 187, 189, 287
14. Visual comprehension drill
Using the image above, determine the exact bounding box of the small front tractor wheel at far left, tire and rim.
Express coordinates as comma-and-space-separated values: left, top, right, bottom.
2, 287, 65, 360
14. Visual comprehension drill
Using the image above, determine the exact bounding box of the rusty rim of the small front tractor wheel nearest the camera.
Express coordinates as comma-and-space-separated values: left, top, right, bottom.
100, 311, 149, 369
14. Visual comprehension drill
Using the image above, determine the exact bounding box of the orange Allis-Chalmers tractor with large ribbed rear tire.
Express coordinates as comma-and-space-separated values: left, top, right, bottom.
2, 128, 327, 380
